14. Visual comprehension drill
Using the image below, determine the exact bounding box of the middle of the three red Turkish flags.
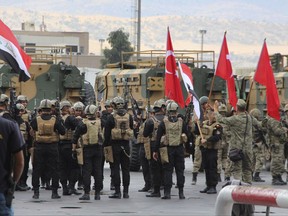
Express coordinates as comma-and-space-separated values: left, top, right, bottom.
215, 32, 238, 110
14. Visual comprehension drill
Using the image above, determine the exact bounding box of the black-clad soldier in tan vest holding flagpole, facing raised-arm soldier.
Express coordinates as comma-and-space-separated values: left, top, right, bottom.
195, 110, 223, 194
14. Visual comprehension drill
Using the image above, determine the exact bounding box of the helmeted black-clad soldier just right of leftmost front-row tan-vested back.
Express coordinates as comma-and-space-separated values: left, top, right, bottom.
59, 100, 81, 196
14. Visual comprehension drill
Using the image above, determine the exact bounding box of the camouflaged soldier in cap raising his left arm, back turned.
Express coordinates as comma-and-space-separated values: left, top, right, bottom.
214, 99, 252, 184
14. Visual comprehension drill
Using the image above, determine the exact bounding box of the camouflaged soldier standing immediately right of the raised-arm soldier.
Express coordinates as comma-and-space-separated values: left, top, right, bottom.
250, 108, 266, 182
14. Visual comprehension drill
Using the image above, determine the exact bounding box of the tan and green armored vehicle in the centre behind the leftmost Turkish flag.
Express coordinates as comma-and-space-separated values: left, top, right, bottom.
94, 50, 226, 171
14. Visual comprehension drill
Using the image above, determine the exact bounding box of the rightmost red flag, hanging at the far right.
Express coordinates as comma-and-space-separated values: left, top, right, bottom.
254, 40, 280, 120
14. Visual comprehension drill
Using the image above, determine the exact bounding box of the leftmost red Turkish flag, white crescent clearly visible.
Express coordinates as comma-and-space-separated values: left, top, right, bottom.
165, 28, 185, 108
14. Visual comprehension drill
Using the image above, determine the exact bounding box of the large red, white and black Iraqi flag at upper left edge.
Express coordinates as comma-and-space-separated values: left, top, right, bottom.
0, 20, 32, 82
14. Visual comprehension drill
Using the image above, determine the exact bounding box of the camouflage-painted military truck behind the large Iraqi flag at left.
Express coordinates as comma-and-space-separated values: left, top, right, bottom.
0, 47, 96, 110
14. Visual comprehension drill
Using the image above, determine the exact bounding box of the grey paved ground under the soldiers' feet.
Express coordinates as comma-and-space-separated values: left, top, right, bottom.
13, 158, 288, 216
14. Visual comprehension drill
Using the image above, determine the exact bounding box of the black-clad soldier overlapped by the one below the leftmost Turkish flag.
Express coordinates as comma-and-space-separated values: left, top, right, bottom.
143, 99, 166, 197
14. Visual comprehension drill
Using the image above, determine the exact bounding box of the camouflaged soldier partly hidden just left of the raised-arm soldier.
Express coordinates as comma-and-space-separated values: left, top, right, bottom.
217, 104, 231, 182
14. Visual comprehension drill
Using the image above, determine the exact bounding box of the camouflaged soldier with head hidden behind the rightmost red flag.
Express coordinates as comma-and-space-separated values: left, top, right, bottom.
267, 113, 287, 185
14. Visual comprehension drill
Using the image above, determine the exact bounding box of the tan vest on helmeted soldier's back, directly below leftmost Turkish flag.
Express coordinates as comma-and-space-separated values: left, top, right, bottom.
163, 117, 183, 146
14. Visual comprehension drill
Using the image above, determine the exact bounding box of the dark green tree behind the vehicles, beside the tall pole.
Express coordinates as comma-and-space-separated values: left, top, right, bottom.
102, 28, 134, 65
